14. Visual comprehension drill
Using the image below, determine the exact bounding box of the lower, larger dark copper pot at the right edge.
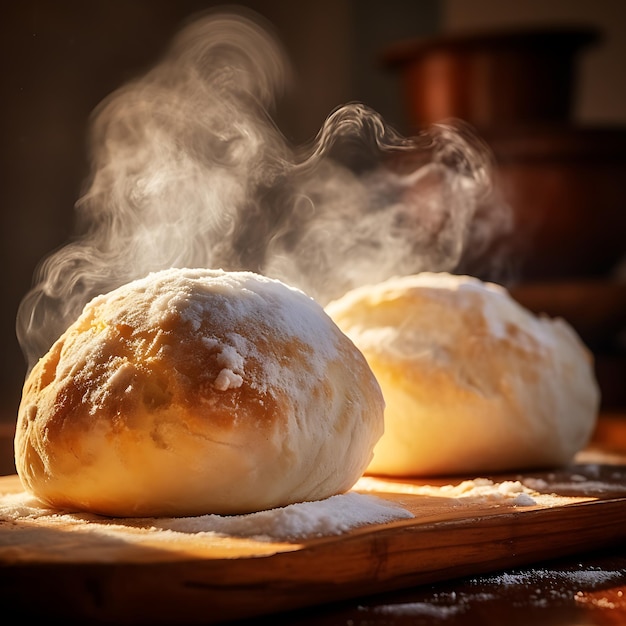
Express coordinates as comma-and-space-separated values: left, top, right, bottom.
483, 125, 626, 280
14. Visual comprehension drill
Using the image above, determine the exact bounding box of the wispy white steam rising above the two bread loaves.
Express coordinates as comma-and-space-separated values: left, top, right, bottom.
17, 9, 510, 369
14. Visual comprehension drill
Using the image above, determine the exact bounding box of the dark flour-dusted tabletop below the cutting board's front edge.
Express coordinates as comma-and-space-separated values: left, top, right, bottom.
249, 545, 626, 626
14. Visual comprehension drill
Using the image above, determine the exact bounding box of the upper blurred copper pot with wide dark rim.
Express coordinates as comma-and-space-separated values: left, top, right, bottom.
384, 27, 599, 128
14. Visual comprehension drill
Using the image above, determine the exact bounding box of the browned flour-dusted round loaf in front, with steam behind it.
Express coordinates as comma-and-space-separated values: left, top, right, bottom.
15, 269, 384, 516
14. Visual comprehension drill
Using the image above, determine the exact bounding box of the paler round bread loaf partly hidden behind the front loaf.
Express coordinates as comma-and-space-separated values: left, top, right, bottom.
326, 273, 599, 476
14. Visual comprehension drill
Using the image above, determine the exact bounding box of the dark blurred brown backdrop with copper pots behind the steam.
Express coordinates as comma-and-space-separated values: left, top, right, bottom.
0, 0, 626, 444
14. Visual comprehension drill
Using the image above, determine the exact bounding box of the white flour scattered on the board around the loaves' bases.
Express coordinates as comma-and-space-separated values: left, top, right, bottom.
0, 466, 606, 541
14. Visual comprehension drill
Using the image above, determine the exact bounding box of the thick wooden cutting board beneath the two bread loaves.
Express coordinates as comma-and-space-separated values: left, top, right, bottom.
0, 454, 626, 624
